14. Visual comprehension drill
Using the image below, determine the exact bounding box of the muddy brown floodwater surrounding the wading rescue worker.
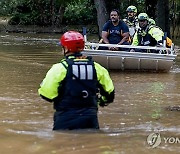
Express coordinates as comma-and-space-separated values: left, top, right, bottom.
0, 33, 180, 154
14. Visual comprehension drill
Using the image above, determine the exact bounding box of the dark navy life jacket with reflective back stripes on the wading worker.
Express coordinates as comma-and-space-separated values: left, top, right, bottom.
54, 58, 98, 110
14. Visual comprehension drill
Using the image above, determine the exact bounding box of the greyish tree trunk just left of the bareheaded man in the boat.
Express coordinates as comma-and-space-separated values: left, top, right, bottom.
94, 0, 109, 37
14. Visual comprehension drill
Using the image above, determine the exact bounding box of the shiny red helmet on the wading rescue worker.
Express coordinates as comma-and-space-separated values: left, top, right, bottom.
60, 31, 84, 52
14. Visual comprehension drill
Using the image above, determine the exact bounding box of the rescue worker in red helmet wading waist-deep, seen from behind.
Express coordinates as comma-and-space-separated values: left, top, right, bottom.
38, 31, 114, 130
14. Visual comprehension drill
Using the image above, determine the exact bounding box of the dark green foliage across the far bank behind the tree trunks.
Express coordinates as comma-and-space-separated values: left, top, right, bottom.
0, 0, 180, 25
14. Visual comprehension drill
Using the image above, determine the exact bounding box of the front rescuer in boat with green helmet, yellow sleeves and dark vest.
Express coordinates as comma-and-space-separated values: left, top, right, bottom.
130, 13, 164, 53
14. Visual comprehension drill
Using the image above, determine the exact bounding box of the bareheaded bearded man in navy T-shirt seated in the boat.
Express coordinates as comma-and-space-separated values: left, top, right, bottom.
99, 9, 130, 51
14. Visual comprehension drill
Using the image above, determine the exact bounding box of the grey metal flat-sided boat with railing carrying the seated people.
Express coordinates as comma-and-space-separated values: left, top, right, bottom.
83, 42, 177, 72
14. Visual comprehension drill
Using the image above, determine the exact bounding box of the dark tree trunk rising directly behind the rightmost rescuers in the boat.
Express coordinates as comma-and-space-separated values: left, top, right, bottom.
157, 0, 170, 37
